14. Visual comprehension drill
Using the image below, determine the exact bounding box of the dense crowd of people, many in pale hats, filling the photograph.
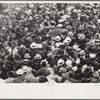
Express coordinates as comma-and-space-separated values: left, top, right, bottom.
0, 3, 100, 83
